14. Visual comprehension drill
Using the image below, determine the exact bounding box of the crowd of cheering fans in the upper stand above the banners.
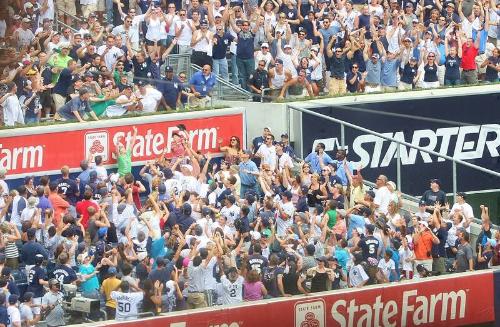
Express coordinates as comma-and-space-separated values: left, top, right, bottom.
0, 0, 500, 126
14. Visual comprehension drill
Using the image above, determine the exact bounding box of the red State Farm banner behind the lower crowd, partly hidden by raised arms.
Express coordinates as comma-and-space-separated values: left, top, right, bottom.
0, 109, 244, 178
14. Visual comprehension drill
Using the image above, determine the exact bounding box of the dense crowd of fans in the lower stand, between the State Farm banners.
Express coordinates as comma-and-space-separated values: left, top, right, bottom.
0, 126, 500, 326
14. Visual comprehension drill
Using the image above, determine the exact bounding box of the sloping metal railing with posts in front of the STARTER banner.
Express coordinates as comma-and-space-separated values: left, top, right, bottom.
287, 105, 500, 205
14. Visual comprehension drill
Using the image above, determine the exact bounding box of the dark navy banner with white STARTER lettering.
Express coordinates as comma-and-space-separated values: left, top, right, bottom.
302, 93, 500, 195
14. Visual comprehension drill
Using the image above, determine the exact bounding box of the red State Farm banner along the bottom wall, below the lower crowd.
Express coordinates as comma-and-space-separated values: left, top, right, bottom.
107, 271, 495, 327
